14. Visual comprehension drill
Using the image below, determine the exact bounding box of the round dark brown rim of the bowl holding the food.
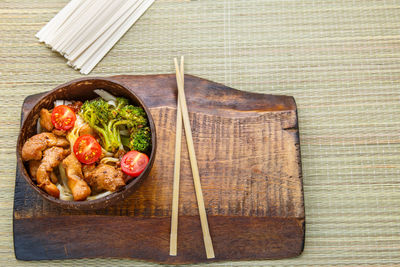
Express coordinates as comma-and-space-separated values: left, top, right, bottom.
16, 77, 157, 211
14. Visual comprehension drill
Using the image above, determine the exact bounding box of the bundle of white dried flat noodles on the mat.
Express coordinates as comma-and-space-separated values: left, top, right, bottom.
36, 0, 155, 74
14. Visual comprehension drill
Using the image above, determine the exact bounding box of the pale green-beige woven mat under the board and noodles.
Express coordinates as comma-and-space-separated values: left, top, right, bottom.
0, 0, 400, 266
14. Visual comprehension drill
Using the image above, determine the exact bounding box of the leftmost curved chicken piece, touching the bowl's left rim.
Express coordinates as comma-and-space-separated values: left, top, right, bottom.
22, 133, 69, 161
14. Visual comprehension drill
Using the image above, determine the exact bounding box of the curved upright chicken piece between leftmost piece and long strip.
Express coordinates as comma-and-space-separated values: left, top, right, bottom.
36, 146, 68, 198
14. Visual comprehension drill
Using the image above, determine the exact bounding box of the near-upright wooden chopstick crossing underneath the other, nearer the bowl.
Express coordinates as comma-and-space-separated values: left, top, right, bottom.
169, 57, 185, 256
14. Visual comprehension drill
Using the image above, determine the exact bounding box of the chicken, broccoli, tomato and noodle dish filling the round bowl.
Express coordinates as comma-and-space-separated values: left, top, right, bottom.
21, 90, 151, 201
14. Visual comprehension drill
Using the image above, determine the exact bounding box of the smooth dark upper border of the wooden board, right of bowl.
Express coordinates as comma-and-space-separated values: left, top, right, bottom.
110, 74, 296, 116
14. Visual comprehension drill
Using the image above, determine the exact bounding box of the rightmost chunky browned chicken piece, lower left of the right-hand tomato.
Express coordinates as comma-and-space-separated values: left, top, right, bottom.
84, 164, 125, 192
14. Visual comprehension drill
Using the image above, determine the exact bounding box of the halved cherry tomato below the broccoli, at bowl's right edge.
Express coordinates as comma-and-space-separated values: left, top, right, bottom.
121, 150, 149, 177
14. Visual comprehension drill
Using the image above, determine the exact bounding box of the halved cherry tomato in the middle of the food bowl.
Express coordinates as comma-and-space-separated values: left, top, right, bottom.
74, 134, 101, 164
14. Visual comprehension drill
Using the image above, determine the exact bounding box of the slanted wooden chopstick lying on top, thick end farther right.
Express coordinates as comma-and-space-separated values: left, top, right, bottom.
174, 58, 215, 259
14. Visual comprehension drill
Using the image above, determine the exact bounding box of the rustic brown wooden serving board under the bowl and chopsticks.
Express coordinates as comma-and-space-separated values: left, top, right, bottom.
14, 74, 305, 264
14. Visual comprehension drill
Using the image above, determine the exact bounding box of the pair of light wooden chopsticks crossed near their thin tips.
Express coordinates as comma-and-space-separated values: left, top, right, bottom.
169, 57, 215, 259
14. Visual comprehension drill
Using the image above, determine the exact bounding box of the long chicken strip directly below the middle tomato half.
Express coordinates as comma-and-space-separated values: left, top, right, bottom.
62, 153, 92, 201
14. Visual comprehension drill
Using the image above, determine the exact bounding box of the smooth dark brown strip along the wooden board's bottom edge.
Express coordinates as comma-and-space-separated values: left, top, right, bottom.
14, 215, 304, 264
